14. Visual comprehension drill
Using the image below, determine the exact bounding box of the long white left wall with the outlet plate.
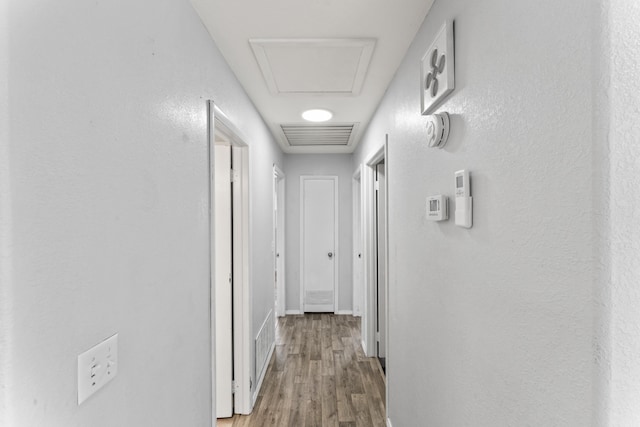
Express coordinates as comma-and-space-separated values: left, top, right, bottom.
0, 0, 282, 427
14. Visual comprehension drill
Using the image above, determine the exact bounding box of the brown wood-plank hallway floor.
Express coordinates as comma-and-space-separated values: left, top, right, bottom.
218, 314, 386, 427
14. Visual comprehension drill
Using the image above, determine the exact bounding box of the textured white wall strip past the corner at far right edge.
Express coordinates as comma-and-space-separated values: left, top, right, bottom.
603, 0, 640, 426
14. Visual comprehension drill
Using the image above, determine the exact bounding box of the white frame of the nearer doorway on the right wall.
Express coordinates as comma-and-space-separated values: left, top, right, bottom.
361, 140, 389, 358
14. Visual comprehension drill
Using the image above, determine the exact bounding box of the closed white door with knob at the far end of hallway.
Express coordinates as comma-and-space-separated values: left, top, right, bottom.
300, 176, 338, 312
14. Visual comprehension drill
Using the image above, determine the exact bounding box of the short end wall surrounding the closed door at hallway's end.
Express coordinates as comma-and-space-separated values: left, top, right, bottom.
284, 154, 354, 312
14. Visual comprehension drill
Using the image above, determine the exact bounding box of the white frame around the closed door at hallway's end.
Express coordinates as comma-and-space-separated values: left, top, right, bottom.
300, 175, 340, 314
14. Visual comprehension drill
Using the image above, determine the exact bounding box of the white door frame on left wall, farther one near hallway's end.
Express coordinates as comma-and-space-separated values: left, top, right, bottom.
273, 164, 286, 317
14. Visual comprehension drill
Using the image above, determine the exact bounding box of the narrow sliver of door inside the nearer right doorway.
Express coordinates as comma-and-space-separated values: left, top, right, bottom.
376, 163, 387, 369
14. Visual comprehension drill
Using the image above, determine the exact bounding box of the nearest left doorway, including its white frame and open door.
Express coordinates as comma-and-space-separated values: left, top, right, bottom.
208, 101, 251, 420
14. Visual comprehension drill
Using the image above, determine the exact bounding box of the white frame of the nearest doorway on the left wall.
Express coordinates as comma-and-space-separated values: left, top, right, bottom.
207, 100, 252, 425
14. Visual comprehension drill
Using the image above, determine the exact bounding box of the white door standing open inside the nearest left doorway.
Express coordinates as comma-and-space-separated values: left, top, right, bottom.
213, 145, 233, 418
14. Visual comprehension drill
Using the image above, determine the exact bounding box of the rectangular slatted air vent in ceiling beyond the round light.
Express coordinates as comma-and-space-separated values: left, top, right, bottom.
280, 123, 357, 147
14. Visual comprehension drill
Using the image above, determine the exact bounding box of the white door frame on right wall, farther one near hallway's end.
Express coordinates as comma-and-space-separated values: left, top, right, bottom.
351, 165, 364, 317
